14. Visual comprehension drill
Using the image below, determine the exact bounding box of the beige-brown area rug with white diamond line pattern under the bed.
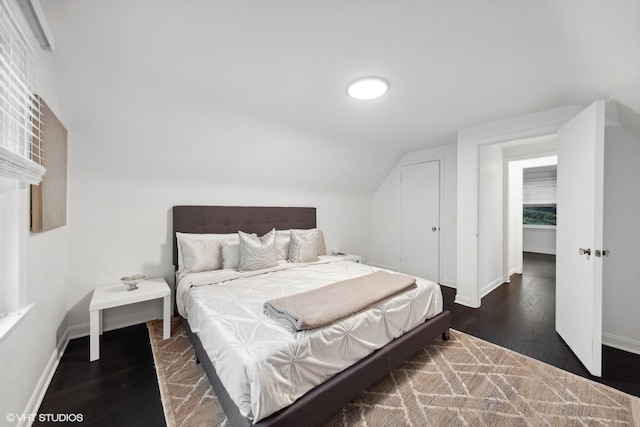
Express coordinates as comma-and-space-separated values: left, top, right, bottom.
147, 320, 640, 427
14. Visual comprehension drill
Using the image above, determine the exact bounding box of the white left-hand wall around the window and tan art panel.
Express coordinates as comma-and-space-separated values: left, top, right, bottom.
0, 19, 71, 426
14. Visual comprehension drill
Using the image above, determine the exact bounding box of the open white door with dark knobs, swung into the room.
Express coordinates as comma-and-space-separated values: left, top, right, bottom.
556, 101, 605, 376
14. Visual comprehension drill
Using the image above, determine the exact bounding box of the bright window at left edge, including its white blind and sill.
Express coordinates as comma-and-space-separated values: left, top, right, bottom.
0, 0, 45, 332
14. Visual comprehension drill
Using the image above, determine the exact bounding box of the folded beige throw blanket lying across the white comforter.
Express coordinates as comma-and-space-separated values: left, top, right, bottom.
264, 271, 416, 330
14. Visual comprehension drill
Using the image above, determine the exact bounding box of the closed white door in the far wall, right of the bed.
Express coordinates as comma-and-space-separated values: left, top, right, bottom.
400, 160, 440, 282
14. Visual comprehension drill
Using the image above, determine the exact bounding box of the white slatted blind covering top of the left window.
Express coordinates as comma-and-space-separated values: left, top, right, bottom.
0, 1, 46, 184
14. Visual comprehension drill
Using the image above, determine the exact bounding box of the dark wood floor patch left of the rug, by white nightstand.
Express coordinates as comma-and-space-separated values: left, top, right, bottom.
34, 324, 166, 427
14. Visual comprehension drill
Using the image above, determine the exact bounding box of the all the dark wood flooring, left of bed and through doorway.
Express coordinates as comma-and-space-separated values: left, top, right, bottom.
34, 254, 640, 426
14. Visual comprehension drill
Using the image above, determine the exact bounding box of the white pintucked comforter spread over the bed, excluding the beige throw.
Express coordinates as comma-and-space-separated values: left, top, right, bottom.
177, 257, 442, 422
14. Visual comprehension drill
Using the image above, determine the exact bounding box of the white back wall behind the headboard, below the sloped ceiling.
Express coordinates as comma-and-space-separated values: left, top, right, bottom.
68, 176, 370, 335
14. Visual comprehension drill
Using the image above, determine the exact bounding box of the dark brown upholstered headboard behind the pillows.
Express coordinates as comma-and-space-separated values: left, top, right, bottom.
173, 206, 316, 268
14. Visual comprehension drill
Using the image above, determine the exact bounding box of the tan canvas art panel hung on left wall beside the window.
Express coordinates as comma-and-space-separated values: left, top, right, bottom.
31, 97, 67, 233
